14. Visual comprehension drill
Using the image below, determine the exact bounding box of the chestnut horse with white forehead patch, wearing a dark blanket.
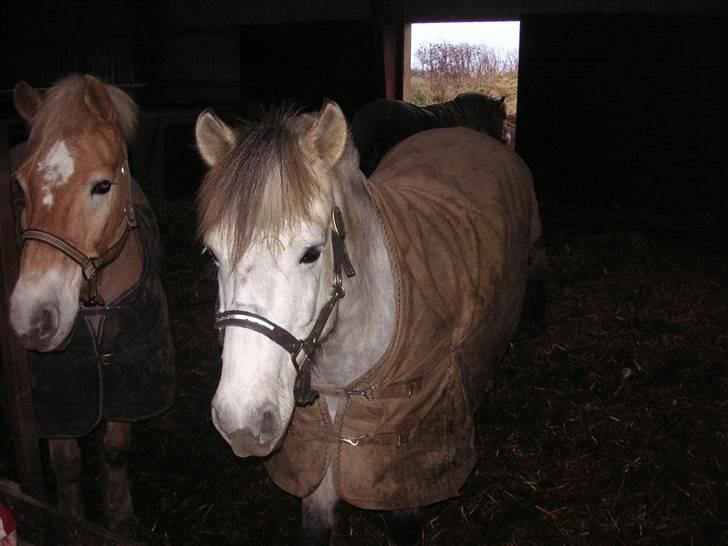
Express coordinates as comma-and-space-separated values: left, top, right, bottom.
10, 76, 174, 532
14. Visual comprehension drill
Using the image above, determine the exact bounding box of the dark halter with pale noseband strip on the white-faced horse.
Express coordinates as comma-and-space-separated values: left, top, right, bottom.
215, 207, 356, 406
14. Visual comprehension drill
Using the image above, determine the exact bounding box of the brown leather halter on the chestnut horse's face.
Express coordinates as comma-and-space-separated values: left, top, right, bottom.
21, 158, 138, 307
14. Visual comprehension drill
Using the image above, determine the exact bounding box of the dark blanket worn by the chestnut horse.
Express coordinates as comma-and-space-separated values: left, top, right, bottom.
28, 183, 174, 438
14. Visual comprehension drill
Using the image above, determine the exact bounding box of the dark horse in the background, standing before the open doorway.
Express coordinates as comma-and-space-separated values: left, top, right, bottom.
351, 93, 506, 176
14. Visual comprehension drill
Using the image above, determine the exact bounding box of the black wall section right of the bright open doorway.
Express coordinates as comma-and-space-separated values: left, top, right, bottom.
518, 15, 728, 209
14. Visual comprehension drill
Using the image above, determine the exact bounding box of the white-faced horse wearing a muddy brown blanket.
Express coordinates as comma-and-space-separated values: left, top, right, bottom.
196, 103, 545, 543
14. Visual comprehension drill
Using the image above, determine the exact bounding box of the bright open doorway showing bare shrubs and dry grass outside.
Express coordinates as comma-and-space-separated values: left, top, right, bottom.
403, 21, 520, 145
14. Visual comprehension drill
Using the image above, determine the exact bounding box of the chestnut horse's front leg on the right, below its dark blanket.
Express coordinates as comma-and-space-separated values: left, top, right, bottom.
102, 421, 138, 534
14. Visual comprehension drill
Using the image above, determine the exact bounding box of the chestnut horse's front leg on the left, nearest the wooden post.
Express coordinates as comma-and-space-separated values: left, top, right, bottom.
48, 439, 86, 518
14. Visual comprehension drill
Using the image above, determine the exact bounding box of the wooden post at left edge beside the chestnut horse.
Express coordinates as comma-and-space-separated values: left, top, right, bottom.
0, 123, 45, 499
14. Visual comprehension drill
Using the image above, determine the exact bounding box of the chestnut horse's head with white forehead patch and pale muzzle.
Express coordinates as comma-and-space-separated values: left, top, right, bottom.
10, 76, 136, 351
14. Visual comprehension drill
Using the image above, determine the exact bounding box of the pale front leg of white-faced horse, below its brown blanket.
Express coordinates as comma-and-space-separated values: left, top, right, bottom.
301, 468, 342, 546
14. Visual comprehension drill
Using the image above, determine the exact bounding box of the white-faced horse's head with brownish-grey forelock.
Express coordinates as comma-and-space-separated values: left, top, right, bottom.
196, 103, 357, 456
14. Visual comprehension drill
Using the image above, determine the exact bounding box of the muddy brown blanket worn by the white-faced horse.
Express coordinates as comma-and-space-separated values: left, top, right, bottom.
266, 128, 544, 510
